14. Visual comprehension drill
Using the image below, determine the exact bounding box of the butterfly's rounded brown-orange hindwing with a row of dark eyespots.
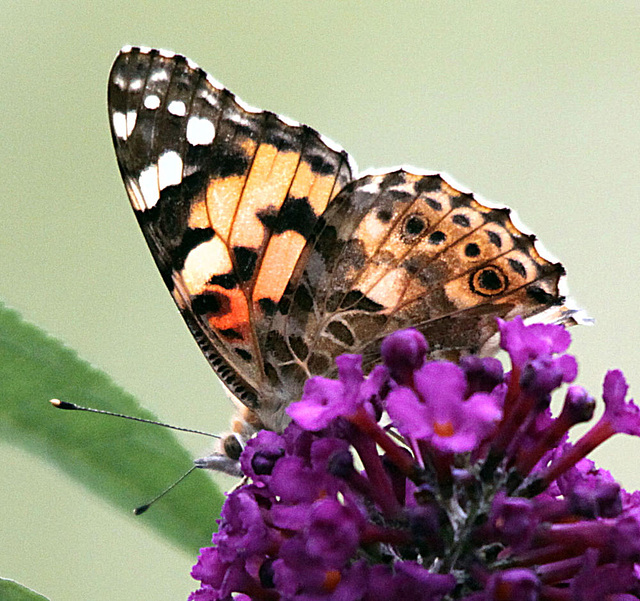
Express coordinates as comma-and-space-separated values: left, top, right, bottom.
280, 170, 564, 374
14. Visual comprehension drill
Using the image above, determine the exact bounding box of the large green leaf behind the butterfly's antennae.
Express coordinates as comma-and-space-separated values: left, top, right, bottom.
0, 303, 223, 556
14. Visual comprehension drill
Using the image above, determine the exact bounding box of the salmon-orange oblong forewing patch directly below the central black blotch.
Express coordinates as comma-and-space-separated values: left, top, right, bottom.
253, 230, 306, 304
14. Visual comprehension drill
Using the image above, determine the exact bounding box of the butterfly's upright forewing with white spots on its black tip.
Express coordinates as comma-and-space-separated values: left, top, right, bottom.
108, 48, 351, 418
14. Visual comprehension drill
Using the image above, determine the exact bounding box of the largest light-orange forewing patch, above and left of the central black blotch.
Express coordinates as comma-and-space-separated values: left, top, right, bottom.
229, 144, 300, 249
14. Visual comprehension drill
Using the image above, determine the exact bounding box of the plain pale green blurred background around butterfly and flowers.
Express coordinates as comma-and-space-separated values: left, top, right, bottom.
0, 0, 640, 601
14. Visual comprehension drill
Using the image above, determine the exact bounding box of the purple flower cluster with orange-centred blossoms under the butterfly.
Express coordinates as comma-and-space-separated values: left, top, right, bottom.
190, 318, 640, 601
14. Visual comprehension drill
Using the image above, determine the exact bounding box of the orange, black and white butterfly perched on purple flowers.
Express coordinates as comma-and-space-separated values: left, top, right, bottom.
108, 47, 575, 473
